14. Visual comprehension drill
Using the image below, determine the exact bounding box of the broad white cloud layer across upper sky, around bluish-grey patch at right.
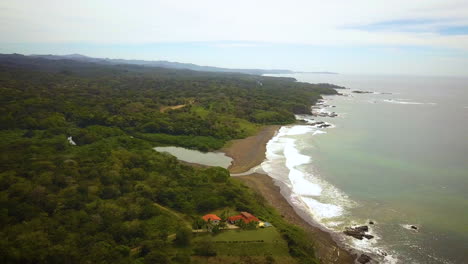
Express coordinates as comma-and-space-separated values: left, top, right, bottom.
0, 0, 468, 49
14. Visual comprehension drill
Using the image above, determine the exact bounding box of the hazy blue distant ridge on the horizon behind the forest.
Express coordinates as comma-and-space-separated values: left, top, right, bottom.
29, 54, 294, 75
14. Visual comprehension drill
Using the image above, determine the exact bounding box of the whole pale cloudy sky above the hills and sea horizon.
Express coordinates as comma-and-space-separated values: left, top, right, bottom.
0, 0, 468, 76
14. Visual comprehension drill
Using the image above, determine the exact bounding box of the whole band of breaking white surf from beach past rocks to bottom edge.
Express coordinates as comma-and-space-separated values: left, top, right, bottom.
260, 125, 398, 263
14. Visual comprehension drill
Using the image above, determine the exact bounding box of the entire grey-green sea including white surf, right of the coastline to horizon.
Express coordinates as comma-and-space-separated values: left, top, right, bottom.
262, 74, 468, 263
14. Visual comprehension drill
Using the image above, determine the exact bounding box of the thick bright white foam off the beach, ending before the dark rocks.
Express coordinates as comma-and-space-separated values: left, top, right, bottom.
262, 126, 352, 226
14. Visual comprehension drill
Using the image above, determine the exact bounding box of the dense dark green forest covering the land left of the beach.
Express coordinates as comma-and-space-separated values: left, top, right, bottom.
0, 55, 336, 263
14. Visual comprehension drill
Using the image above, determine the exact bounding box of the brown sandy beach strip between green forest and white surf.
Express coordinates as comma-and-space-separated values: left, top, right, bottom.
221, 125, 355, 264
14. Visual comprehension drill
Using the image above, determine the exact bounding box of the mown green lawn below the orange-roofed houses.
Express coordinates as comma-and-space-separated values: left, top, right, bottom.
194, 227, 289, 256
